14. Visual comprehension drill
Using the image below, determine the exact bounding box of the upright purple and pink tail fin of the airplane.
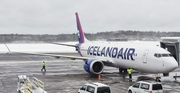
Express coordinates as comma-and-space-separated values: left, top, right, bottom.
75, 12, 88, 43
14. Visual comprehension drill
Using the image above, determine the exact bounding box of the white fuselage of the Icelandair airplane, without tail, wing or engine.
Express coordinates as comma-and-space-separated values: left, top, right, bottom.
79, 43, 178, 73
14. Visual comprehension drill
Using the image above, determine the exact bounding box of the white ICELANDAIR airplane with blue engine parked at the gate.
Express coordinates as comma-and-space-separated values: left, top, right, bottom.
50, 13, 178, 76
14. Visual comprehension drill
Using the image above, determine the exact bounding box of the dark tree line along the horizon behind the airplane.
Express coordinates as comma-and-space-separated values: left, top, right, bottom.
0, 30, 180, 43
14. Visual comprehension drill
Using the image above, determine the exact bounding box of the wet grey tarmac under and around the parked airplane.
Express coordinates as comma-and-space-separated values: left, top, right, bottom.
0, 54, 180, 93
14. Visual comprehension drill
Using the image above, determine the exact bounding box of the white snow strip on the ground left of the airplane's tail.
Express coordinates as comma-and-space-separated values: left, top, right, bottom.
0, 42, 76, 53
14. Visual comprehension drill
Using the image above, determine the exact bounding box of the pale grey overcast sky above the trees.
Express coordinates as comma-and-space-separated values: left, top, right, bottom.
0, 0, 180, 34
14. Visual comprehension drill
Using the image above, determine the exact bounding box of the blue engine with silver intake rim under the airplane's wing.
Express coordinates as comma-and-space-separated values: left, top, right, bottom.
84, 60, 104, 74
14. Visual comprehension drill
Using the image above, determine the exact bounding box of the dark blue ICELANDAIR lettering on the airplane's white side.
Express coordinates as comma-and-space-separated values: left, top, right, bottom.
87, 46, 135, 60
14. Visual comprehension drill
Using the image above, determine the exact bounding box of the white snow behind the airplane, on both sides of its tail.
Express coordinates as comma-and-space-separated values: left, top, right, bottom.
0, 41, 159, 53
